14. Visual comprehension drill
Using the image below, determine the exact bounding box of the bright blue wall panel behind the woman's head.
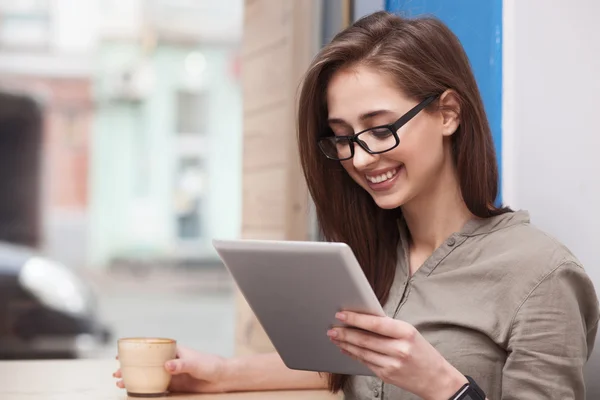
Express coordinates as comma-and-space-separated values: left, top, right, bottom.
386, 0, 502, 201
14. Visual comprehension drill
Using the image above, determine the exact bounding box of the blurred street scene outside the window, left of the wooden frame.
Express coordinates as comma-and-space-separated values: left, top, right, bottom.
0, 0, 243, 358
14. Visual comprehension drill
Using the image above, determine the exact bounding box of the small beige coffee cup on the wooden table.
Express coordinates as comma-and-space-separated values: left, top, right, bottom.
118, 337, 177, 397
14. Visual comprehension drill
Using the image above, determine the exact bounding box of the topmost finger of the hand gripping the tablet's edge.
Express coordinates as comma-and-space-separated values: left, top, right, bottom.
335, 311, 416, 339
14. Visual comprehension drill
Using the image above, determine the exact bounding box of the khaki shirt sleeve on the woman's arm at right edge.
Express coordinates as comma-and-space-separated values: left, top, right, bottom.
502, 262, 599, 400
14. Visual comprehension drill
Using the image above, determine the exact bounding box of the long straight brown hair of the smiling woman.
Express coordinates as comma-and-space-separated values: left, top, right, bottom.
298, 11, 509, 392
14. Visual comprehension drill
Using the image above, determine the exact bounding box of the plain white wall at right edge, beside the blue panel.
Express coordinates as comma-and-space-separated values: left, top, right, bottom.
503, 0, 600, 286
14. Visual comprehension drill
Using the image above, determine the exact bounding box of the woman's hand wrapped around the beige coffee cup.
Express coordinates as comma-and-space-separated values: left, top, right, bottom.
113, 346, 226, 393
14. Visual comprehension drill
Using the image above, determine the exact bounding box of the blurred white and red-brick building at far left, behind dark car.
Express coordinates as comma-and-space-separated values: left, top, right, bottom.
0, 0, 93, 263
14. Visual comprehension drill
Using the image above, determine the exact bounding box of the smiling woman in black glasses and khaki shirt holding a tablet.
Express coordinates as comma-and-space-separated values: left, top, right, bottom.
117, 12, 599, 400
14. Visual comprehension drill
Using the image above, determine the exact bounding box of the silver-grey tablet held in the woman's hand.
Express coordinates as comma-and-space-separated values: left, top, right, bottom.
213, 240, 385, 376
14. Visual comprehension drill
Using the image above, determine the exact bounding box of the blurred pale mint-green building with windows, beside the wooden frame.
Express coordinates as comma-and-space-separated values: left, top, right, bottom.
89, 1, 242, 265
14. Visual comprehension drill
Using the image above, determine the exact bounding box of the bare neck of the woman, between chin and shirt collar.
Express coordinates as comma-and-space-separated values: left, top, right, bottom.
402, 160, 474, 254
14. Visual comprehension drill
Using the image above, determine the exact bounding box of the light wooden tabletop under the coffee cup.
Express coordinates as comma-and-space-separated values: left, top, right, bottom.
0, 360, 340, 400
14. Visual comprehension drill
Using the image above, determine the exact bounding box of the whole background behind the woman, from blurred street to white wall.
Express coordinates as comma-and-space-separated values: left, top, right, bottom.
0, 0, 600, 368
